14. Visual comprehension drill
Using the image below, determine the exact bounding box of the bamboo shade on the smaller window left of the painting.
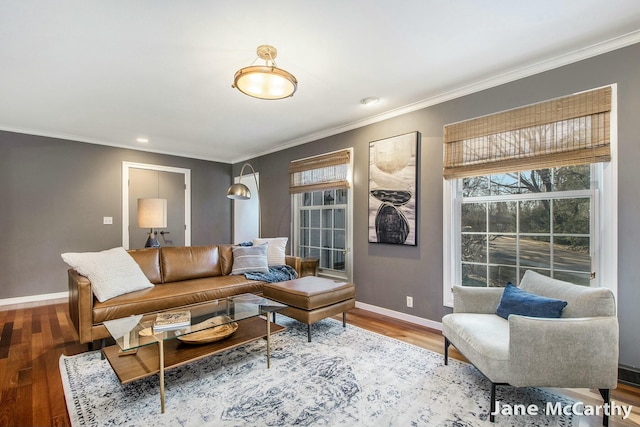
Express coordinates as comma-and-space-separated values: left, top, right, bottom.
289, 150, 351, 194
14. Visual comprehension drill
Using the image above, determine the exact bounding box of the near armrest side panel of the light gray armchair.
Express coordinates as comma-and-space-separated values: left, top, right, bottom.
509, 315, 619, 389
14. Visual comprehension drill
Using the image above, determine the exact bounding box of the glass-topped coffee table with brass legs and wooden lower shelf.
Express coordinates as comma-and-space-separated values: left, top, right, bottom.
102, 294, 286, 413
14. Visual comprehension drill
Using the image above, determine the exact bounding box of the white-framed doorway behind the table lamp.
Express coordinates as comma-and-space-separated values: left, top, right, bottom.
122, 162, 191, 249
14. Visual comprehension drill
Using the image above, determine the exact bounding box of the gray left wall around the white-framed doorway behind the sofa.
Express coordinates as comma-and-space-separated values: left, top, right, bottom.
0, 131, 231, 299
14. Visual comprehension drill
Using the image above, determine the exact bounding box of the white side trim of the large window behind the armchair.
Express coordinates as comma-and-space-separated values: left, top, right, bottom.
442, 83, 618, 307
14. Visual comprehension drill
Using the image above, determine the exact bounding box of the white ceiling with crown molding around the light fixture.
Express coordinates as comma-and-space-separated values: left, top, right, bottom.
0, 0, 640, 163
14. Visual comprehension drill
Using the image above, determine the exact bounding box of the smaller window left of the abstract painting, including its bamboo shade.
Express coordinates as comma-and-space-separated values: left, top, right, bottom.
289, 150, 352, 280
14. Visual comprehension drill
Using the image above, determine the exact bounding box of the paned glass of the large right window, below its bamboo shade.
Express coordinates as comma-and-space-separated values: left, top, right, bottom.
458, 165, 598, 287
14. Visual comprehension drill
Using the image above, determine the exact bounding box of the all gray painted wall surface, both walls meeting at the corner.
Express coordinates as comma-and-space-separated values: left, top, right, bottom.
0, 44, 640, 367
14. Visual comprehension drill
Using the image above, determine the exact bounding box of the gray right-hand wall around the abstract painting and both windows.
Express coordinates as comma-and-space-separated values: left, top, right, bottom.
250, 44, 640, 367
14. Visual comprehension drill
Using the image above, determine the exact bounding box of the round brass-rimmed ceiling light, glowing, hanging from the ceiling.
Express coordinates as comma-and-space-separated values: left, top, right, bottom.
231, 45, 298, 99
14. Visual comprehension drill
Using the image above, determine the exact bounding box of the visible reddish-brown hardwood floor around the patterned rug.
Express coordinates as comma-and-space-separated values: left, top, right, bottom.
0, 300, 640, 427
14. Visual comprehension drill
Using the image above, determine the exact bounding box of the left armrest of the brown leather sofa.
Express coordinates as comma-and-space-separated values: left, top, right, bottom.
68, 270, 93, 344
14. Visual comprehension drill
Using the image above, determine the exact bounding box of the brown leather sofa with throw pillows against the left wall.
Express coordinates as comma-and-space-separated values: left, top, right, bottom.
68, 245, 300, 344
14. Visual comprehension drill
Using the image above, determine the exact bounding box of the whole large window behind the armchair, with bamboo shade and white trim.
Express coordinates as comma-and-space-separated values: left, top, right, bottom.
443, 85, 617, 306
